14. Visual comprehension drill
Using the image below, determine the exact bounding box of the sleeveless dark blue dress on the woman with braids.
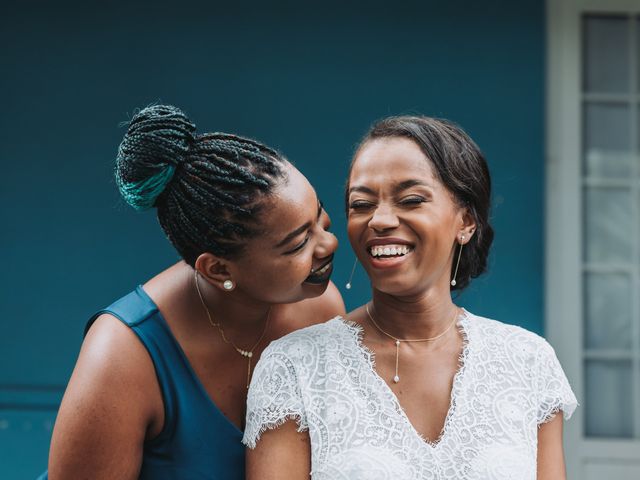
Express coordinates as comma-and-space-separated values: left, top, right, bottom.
40, 286, 245, 480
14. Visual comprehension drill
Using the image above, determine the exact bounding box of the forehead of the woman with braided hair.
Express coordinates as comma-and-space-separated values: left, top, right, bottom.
258, 166, 318, 244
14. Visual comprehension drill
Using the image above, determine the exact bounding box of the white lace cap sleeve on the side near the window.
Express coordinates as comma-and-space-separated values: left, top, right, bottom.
537, 341, 578, 424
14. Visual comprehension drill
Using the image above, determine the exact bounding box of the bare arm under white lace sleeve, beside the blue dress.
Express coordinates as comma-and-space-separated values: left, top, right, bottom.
247, 420, 311, 480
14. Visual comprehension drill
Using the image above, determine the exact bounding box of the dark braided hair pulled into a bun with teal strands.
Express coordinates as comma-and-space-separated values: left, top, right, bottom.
115, 105, 286, 266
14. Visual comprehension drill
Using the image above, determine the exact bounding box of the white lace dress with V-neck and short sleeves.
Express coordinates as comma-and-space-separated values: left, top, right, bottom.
243, 311, 577, 480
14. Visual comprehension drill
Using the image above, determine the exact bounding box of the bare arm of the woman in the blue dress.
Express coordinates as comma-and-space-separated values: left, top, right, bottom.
49, 315, 163, 480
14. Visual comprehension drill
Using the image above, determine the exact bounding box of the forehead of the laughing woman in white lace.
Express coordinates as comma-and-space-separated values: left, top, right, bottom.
349, 137, 439, 185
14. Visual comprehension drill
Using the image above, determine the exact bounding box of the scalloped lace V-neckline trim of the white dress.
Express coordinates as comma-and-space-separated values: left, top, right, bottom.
340, 308, 470, 450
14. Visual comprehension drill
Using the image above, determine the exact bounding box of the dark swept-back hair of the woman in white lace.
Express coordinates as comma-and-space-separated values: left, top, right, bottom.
345, 116, 493, 290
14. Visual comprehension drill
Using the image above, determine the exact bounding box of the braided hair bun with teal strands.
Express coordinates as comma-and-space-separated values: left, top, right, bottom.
115, 105, 196, 210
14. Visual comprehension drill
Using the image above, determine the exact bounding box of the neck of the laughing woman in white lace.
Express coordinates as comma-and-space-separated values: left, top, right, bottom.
369, 290, 458, 340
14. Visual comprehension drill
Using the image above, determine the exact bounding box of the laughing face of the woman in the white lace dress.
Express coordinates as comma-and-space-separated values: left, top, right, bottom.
347, 137, 473, 296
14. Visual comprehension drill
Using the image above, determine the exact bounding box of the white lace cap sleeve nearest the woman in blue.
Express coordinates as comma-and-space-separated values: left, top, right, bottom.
242, 342, 308, 448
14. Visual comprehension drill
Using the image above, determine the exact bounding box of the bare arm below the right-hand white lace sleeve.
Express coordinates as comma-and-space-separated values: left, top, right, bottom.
538, 411, 567, 480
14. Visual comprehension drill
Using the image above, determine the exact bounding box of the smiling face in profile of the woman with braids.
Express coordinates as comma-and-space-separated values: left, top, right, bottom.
227, 165, 338, 303
